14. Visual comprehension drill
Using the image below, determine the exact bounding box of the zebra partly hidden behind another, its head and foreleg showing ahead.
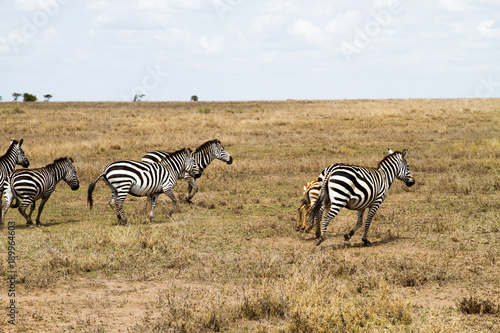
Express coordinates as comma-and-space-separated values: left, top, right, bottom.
141, 139, 233, 202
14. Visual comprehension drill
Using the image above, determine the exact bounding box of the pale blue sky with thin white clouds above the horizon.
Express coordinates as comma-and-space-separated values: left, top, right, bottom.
0, 0, 500, 101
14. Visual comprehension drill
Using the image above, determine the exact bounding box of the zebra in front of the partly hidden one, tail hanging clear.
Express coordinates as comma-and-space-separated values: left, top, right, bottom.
87, 148, 199, 224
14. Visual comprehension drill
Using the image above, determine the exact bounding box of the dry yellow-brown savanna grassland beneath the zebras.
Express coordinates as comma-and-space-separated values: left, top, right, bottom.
0, 99, 500, 332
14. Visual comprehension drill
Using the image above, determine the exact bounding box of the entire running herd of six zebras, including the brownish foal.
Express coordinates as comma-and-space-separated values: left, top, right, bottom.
0, 139, 415, 245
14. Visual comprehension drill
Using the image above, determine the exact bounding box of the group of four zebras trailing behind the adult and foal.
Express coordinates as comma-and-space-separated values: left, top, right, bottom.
0, 139, 233, 228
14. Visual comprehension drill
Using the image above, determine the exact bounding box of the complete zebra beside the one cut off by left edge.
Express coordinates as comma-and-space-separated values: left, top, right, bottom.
3, 157, 80, 225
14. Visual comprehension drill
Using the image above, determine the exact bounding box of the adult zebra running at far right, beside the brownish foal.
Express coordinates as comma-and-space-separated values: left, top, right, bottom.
308, 149, 415, 245
